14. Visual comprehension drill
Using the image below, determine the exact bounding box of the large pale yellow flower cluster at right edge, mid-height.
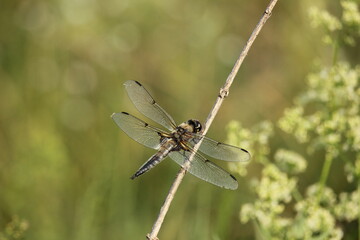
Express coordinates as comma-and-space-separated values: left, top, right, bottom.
279, 63, 360, 157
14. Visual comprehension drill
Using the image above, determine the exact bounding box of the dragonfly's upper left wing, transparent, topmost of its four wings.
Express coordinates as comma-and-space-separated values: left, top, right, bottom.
124, 80, 176, 131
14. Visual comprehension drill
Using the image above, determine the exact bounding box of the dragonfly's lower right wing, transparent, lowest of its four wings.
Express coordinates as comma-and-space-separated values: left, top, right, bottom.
169, 150, 238, 190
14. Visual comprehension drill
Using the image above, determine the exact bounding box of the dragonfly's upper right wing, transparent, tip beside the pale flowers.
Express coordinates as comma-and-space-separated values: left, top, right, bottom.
190, 135, 251, 162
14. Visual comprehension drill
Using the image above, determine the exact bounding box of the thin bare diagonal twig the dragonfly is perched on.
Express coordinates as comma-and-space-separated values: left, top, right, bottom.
146, 0, 278, 240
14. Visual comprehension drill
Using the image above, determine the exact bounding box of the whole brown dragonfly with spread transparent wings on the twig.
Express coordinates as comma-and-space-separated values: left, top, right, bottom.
111, 80, 251, 190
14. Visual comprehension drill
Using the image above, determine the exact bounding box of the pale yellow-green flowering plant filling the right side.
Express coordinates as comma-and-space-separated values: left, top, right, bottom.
228, 0, 360, 240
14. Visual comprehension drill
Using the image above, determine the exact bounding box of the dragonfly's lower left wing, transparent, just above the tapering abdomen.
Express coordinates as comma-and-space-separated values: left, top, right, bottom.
111, 112, 164, 149
